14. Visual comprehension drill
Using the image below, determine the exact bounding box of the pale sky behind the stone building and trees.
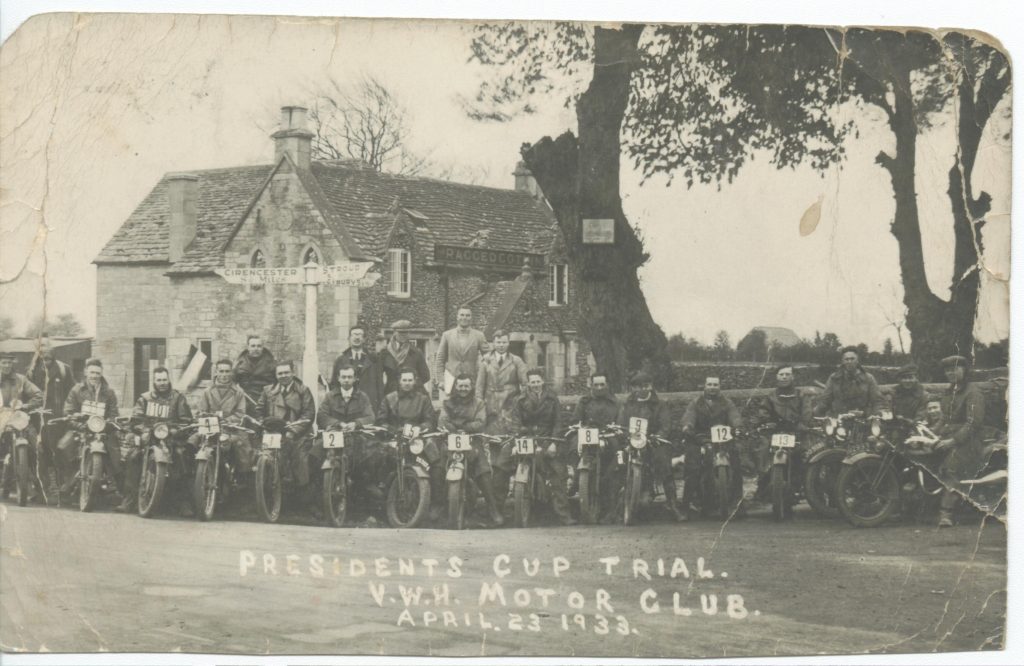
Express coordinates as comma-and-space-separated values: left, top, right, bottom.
0, 7, 1011, 348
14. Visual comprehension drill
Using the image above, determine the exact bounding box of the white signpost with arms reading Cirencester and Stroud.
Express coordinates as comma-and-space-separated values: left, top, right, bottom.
215, 261, 381, 396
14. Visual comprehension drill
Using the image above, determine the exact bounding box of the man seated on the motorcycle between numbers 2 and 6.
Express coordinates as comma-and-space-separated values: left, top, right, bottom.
377, 369, 444, 521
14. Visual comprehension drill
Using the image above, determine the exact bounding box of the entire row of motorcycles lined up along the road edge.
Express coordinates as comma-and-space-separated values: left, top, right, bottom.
2, 401, 1007, 529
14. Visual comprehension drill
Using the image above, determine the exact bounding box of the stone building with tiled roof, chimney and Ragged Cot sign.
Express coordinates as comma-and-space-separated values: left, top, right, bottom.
94, 107, 593, 399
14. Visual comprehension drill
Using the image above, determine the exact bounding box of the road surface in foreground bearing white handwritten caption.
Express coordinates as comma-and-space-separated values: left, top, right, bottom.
0, 504, 1007, 657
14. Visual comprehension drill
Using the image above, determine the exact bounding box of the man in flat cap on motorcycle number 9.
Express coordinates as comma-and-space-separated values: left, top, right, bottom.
605, 371, 686, 522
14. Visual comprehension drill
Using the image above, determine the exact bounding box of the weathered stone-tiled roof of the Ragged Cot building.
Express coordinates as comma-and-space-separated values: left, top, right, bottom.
94, 158, 556, 274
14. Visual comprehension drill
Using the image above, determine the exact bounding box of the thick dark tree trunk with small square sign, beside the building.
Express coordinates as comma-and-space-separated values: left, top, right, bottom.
523, 26, 671, 389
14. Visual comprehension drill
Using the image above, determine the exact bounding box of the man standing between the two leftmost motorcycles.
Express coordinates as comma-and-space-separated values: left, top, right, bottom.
27, 335, 75, 503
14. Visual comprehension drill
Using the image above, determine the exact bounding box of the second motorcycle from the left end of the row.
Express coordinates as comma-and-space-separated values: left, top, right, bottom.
50, 412, 131, 511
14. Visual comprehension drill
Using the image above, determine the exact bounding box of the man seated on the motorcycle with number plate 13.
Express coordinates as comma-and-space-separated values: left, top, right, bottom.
757, 366, 811, 501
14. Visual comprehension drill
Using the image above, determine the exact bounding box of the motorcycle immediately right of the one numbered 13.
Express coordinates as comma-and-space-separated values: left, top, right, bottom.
804, 412, 876, 517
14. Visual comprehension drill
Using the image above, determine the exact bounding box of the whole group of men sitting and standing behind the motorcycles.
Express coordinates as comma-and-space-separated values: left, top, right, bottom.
0, 307, 999, 526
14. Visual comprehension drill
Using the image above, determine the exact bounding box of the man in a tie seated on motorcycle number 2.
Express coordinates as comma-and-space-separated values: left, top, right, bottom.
313, 363, 383, 514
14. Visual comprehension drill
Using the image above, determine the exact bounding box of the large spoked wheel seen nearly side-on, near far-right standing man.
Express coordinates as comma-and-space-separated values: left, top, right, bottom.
836, 457, 899, 528
